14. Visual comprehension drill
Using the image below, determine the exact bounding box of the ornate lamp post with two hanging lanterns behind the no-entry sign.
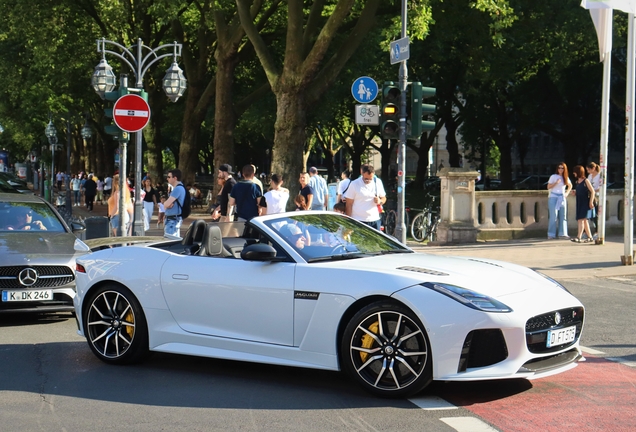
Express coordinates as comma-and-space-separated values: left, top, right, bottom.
92, 38, 186, 236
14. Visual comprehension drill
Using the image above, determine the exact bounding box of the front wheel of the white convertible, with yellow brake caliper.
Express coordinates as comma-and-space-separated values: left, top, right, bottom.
340, 301, 433, 398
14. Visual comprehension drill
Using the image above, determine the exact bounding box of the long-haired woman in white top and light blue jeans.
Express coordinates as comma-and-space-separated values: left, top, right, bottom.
548, 162, 572, 240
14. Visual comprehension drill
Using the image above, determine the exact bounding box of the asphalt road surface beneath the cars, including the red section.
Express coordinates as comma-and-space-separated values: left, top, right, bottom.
0, 278, 636, 432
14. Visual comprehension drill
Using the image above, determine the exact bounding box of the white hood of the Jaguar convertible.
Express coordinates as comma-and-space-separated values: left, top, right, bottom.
320, 253, 553, 298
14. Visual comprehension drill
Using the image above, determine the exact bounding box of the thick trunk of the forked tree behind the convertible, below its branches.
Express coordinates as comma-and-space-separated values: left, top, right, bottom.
272, 91, 307, 209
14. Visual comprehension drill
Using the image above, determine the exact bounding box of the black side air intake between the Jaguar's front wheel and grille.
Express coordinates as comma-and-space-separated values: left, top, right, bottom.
457, 329, 508, 372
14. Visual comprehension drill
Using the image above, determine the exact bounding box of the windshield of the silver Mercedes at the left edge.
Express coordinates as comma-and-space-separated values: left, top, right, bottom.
0, 202, 66, 232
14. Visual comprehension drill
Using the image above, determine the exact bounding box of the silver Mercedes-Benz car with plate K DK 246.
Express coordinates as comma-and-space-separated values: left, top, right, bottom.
0, 193, 90, 314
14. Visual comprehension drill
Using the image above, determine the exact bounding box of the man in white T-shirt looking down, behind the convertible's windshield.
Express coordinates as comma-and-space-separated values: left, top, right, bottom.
344, 164, 386, 231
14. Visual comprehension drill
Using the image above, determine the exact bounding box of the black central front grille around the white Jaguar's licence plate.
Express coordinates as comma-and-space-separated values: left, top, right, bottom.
526, 307, 584, 353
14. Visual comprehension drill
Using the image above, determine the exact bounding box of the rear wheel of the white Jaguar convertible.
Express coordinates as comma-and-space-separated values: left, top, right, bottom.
84, 284, 149, 364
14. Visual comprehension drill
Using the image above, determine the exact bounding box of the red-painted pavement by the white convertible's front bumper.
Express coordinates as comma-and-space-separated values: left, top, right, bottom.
437, 355, 636, 432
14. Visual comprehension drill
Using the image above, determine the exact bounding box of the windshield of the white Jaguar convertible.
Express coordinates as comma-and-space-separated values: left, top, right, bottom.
265, 212, 412, 262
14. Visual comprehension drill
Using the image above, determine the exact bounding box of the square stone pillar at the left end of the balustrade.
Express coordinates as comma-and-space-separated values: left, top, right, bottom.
437, 168, 479, 244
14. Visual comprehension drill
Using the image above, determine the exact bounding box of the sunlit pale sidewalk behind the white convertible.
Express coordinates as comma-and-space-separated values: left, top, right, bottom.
66, 204, 636, 280
